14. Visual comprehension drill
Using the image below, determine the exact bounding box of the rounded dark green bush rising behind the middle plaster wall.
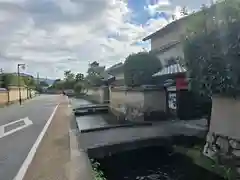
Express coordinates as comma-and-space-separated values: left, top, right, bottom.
124, 52, 162, 86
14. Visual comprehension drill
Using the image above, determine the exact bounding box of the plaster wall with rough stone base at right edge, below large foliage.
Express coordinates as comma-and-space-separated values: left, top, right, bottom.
203, 96, 240, 173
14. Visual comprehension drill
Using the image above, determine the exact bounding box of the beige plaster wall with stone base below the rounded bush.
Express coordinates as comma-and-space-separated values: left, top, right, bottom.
109, 87, 166, 121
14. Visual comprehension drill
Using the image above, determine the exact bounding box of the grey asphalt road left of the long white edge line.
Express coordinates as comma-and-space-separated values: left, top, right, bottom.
0, 95, 59, 180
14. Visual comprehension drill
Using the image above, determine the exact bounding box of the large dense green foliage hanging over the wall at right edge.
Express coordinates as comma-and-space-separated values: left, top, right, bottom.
184, 0, 240, 96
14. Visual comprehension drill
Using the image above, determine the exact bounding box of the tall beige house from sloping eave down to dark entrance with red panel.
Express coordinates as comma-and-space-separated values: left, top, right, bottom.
143, 11, 212, 120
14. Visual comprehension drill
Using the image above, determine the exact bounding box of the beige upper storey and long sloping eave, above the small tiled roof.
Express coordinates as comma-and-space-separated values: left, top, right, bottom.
143, 2, 224, 66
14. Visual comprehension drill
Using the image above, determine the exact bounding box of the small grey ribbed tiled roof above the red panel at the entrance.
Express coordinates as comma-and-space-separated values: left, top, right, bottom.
153, 64, 187, 76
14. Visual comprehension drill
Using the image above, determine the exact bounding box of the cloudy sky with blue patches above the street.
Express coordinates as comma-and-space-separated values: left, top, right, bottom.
0, 0, 210, 78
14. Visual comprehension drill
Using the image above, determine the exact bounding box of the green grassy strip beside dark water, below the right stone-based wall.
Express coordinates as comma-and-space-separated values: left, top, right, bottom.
173, 146, 237, 180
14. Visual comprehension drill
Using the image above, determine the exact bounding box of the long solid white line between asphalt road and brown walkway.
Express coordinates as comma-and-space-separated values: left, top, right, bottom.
13, 104, 59, 180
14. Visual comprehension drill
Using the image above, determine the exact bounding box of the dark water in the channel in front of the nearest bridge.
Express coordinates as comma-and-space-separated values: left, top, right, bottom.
94, 147, 223, 180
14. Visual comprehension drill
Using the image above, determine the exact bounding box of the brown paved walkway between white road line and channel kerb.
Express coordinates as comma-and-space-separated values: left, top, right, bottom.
24, 97, 70, 180
